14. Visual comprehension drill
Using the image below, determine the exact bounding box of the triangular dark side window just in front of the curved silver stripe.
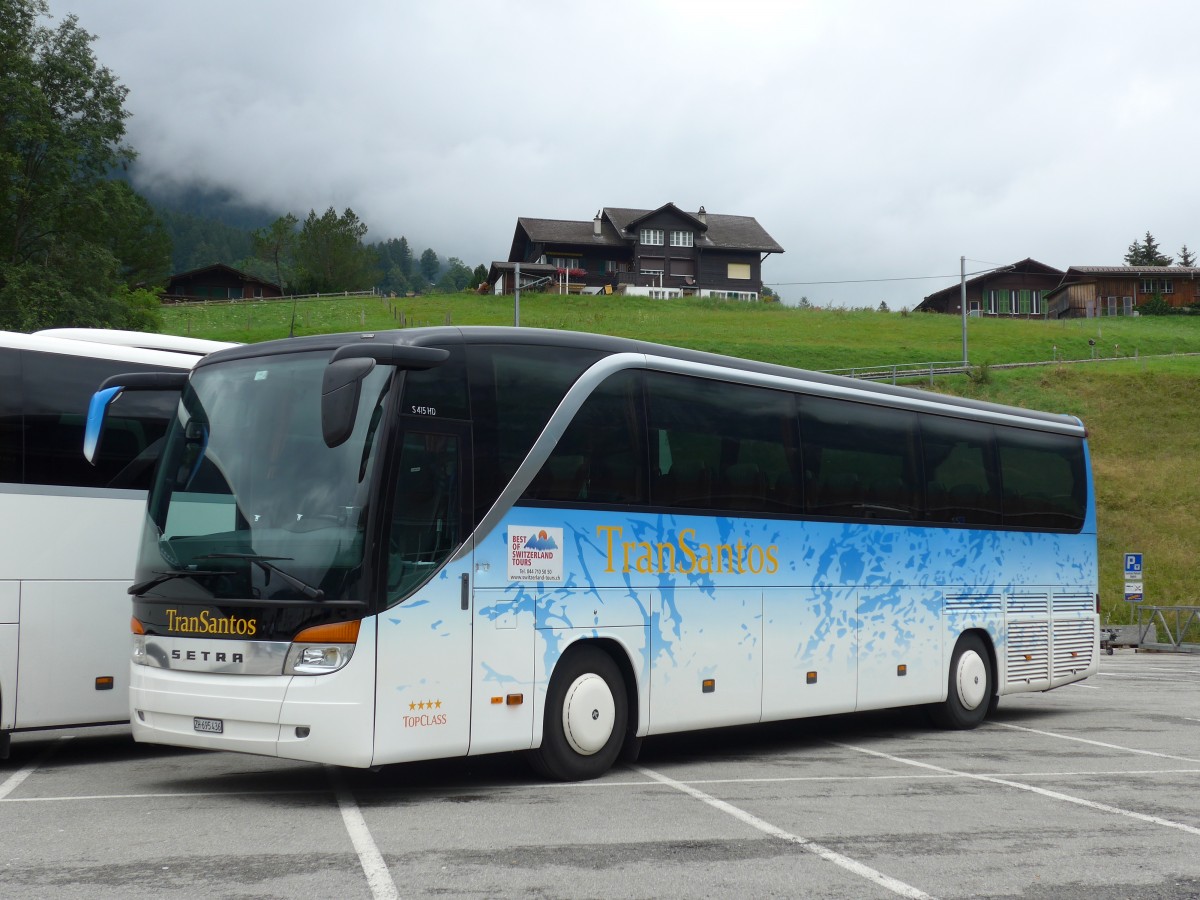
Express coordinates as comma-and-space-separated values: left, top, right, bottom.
467, 344, 604, 522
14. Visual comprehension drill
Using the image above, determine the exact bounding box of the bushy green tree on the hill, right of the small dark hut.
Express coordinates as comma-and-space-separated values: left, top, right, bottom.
296, 206, 379, 293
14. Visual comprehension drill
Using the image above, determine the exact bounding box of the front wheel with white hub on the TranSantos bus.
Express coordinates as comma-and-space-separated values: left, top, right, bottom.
529, 647, 629, 781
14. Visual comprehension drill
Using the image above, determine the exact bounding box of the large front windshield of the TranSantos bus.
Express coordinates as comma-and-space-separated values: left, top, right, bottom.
139, 353, 395, 601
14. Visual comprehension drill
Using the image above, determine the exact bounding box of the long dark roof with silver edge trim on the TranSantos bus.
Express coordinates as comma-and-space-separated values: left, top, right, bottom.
189, 325, 1084, 433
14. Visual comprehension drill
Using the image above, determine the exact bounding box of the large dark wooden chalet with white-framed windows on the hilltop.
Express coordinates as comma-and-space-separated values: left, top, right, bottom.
487, 203, 784, 300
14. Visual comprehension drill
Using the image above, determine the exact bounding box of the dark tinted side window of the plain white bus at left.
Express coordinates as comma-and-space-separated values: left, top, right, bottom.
23, 352, 179, 490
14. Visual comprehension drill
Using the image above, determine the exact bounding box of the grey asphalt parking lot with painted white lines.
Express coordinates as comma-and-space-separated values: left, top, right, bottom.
0, 650, 1200, 900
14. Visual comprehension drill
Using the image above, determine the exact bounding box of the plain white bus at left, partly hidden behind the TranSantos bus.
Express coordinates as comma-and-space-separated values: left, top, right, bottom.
0, 329, 232, 758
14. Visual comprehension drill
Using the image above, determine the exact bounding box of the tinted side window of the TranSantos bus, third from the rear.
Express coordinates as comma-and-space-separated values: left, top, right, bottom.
800, 397, 924, 520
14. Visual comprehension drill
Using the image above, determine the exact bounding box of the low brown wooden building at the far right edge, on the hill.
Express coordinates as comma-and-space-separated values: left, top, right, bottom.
1045, 265, 1200, 318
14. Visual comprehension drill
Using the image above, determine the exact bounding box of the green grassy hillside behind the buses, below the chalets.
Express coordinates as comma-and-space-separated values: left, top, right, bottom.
164, 294, 1200, 623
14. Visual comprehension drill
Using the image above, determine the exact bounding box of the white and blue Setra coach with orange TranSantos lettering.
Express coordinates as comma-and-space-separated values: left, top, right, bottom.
94, 328, 1098, 780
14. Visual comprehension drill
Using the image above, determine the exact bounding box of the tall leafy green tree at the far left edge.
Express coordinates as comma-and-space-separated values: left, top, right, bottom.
0, 0, 169, 330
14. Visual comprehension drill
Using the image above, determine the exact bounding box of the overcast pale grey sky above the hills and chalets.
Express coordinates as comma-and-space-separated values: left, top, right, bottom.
50, 0, 1200, 310
